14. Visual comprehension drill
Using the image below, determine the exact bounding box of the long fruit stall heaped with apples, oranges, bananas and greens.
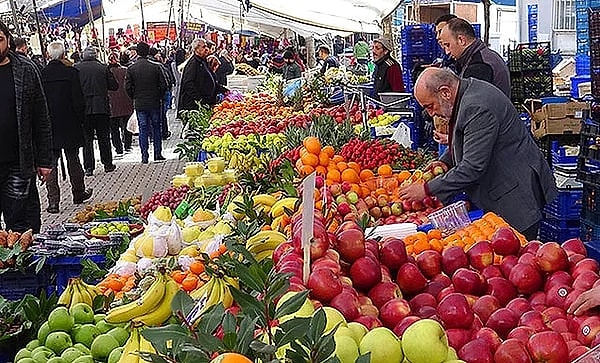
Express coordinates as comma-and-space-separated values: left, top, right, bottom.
0, 69, 600, 363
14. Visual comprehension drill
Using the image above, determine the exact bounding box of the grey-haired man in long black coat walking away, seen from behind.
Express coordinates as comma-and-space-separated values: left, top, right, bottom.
42, 41, 92, 213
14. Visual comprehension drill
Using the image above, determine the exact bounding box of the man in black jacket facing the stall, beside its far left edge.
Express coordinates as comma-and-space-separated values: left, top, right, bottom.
178, 38, 227, 111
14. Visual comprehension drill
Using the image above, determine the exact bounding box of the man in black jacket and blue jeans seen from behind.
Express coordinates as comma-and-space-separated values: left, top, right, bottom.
125, 42, 167, 164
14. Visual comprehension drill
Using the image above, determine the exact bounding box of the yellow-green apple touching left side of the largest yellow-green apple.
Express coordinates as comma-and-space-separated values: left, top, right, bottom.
359, 327, 404, 363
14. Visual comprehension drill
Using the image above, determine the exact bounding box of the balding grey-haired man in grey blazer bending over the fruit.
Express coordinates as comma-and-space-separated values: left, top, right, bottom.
400, 68, 558, 240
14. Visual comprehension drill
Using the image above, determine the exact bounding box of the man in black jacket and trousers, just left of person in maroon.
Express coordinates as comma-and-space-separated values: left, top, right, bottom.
75, 47, 119, 176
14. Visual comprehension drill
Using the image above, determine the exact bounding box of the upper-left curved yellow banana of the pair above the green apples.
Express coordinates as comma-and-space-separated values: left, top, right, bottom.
106, 274, 166, 324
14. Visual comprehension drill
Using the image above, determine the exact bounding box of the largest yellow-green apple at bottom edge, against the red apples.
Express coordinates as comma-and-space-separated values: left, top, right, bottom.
402, 319, 448, 363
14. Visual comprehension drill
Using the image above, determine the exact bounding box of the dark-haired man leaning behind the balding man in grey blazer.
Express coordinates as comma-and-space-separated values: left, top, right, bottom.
439, 18, 510, 97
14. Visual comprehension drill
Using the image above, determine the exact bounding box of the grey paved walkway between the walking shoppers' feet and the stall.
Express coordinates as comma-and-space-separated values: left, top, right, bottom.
39, 110, 185, 226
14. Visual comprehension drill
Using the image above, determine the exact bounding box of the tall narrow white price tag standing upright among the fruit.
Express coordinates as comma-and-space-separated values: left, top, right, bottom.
302, 172, 317, 285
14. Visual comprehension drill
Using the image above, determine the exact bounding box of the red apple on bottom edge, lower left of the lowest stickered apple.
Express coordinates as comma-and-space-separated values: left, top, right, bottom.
527, 331, 569, 363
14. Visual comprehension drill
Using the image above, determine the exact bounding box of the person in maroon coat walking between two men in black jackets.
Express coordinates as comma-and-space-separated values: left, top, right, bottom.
108, 53, 133, 156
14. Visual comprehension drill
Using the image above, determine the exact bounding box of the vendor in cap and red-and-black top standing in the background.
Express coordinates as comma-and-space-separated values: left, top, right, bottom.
372, 38, 404, 95
